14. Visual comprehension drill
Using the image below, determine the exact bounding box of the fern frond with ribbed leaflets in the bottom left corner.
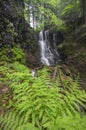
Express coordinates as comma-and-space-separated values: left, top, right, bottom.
0, 112, 38, 130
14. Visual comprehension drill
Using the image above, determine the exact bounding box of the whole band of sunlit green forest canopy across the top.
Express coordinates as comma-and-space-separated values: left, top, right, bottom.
25, 0, 83, 29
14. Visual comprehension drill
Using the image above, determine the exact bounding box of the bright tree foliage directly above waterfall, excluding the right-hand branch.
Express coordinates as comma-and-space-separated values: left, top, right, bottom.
25, 0, 62, 28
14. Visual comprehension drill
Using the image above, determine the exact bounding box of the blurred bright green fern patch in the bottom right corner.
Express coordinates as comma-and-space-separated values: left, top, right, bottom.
45, 114, 86, 130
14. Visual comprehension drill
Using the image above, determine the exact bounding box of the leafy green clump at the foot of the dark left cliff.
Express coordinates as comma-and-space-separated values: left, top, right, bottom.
0, 47, 25, 64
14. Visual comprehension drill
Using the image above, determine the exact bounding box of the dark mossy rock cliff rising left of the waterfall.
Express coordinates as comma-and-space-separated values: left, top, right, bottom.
0, 0, 39, 67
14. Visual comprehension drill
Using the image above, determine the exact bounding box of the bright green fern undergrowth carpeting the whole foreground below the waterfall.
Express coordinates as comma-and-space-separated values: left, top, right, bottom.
0, 47, 86, 130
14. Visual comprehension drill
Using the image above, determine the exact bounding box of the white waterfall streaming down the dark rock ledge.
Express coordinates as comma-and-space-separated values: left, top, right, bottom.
39, 30, 60, 66
